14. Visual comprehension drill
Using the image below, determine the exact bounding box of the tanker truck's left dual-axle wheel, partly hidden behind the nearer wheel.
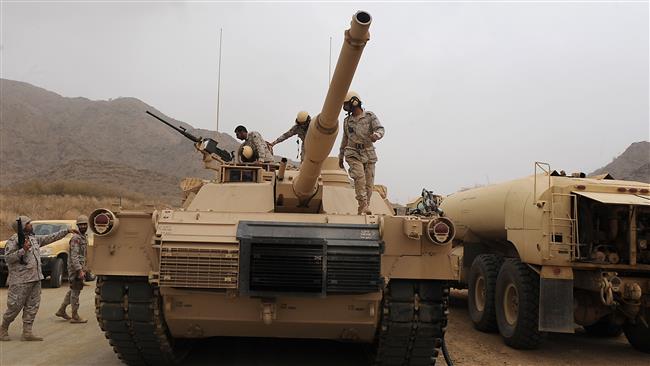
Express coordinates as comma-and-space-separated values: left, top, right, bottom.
467, 254, 503, 332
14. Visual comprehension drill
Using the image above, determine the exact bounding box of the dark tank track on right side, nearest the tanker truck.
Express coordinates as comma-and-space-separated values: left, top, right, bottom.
374, 280, 449, 366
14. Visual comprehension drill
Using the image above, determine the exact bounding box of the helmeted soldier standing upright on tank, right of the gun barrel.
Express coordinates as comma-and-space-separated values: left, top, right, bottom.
339, 91, 384, 215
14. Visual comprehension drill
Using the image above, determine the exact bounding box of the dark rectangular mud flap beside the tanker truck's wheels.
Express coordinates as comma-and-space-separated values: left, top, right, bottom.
539, 277, 574, 333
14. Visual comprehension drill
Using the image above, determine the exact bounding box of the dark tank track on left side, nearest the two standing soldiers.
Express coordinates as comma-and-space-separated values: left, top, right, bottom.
95, 276, 181, 365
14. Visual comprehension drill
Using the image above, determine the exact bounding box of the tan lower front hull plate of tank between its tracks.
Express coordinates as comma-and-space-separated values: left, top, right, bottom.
161, 289, 381, 343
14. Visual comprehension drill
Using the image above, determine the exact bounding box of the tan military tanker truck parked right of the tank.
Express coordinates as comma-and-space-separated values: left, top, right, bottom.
441, 163, 650, 352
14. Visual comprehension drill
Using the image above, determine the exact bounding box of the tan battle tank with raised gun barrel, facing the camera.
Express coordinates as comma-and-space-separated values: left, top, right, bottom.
89, 11, 458, 365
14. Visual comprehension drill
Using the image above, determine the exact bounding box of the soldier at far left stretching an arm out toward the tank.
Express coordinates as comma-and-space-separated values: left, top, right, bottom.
0, 216, 76, 341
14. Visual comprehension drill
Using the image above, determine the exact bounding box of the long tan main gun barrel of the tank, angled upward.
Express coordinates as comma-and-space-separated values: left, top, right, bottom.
293, 11, 372, 201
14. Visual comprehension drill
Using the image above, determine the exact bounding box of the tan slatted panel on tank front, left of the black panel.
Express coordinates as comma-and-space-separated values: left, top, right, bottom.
160, 244, 239, 289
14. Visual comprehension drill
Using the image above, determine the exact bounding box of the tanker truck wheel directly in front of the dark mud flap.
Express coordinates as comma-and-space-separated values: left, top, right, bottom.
496, 258, 542, 349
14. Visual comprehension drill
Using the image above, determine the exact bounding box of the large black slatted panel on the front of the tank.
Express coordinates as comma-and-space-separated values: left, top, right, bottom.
237, 221, 384, 297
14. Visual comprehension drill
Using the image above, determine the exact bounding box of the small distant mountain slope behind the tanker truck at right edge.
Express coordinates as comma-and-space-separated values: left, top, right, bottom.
589, 141, 650, 183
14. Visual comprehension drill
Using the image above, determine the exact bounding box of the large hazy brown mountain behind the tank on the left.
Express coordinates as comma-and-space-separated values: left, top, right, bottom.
0, 79, 239, 186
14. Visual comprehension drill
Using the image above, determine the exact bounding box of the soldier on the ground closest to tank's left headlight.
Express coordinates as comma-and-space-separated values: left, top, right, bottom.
55, 215, 88, 323
